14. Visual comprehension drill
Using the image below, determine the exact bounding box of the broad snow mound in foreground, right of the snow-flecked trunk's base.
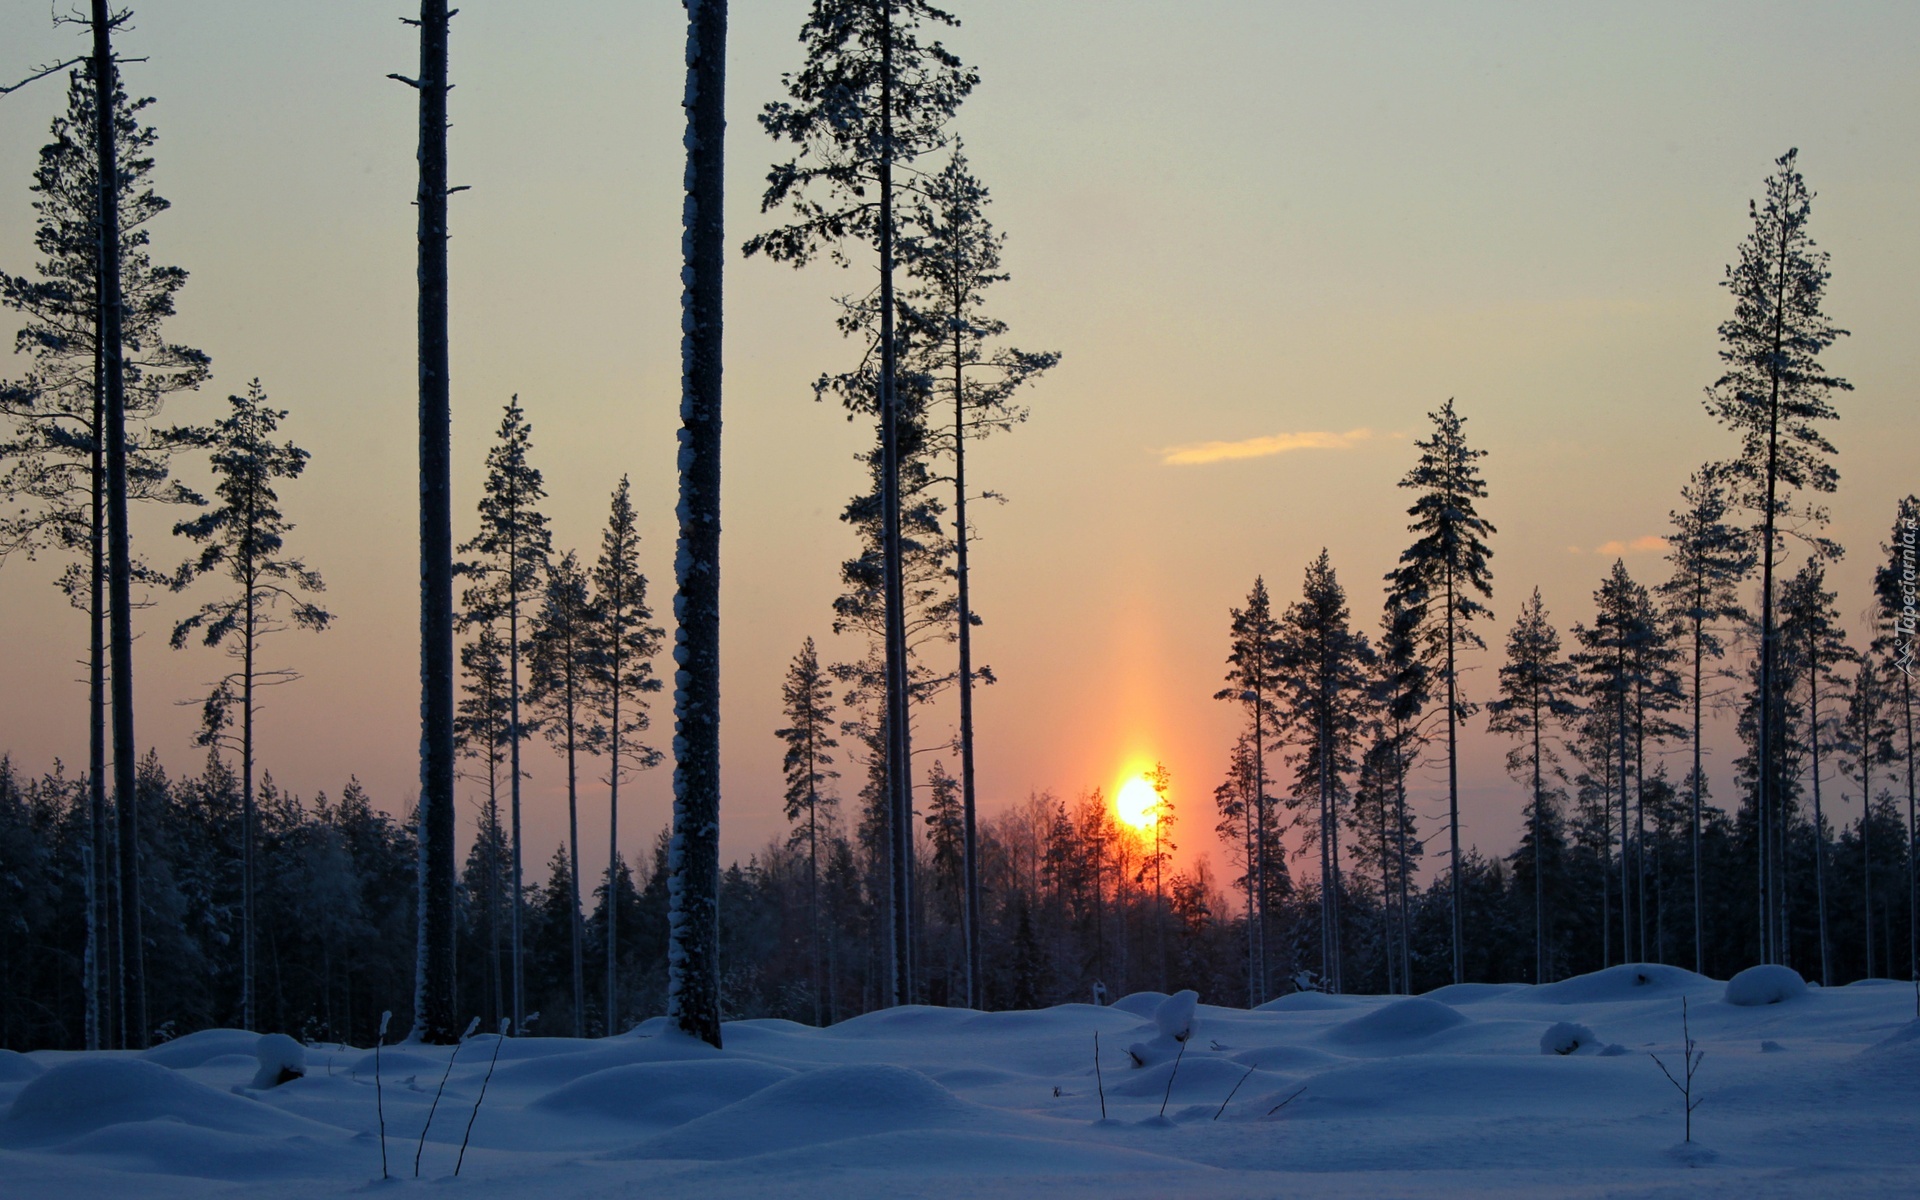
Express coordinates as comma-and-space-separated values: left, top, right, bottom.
620, 1064, 1000, 1160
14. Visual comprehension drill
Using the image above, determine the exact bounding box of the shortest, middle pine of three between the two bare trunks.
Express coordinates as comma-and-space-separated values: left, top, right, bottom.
526, 551, 595, 1035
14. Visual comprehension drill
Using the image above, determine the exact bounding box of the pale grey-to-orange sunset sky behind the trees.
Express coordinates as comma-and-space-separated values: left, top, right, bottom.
0, 0, 1920, 890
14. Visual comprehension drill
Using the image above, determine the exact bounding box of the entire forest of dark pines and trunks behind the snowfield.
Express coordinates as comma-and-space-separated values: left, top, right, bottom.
0, 0, 1920, 1046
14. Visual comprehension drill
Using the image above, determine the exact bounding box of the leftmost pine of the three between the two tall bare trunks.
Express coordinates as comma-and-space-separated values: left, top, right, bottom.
457, 396, 553, 1031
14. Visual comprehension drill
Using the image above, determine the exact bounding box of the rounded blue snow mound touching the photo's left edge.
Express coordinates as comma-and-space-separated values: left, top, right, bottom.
0, 1058, 338, 1144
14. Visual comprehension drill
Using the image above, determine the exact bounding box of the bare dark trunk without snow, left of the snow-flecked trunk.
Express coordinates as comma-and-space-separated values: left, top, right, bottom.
391, 0, 461, 1044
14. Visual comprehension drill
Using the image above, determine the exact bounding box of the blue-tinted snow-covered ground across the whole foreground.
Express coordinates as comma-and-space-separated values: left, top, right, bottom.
0, 966, 1920, 1200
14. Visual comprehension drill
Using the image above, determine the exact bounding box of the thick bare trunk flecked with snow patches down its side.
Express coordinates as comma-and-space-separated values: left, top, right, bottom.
666, 0, 726, 1046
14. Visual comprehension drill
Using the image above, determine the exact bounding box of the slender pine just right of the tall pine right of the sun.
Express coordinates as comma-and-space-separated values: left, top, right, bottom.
1486, 588, 1580, 983
